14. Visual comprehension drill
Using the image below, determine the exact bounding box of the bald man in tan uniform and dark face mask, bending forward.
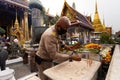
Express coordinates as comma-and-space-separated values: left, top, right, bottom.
35, 16, 81, 80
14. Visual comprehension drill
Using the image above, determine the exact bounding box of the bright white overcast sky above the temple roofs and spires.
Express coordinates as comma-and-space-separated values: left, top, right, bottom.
35, 0, 120, 33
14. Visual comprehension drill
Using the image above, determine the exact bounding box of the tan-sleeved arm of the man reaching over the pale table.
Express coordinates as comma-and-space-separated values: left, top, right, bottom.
45, 36, 69, 62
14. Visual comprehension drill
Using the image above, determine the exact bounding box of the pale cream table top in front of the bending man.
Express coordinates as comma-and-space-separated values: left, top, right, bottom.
44, 59, 101, 80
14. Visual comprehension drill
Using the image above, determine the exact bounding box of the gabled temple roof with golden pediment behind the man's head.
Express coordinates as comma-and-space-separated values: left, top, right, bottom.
61, 1, 94, 30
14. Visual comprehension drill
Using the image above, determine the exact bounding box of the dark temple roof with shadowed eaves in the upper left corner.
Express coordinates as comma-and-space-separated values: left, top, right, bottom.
0, 0, 29, 27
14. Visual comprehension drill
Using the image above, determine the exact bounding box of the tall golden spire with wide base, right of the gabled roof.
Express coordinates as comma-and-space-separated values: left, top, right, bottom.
92, 2, 105, 32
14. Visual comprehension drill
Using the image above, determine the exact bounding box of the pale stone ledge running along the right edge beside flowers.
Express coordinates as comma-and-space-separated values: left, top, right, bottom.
105, 45, 120, 80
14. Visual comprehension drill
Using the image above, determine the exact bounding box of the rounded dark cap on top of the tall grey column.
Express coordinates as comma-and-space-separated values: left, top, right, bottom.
29, 0, 43, 10
